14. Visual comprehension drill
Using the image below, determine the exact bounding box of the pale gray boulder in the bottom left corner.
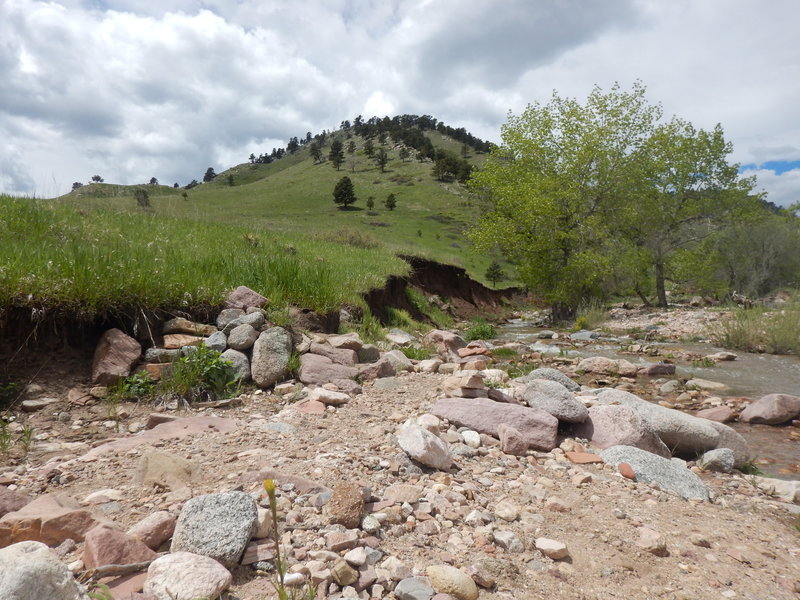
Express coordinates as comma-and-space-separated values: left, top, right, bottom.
0, 542, 89, 600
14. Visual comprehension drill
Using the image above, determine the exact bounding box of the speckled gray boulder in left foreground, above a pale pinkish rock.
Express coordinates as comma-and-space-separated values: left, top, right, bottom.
170, 492, 258, 568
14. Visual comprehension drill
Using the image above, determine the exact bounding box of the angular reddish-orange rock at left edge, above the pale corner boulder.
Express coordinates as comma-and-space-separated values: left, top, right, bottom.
0, 494, 100, 548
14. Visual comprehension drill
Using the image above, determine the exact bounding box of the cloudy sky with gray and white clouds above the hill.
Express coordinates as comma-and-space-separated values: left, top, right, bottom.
0, 0, 800, 206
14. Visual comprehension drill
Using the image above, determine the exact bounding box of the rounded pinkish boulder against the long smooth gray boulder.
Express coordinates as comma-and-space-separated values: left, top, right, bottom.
572, 404, 671, 458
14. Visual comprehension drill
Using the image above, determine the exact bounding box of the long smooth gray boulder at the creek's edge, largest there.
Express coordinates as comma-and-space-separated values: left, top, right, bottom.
597, 389, 720, 454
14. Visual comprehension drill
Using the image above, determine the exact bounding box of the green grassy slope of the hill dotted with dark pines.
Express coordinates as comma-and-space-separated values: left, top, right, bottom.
54, 132, 513, 285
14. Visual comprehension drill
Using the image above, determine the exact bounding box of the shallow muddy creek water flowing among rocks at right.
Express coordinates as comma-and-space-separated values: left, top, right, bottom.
498, 322, 800, 479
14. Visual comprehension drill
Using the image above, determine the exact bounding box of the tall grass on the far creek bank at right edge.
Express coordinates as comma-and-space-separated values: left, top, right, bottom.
712, 295, 800, 355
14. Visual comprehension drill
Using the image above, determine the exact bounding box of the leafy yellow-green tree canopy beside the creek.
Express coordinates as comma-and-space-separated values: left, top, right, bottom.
471, 82, 755, 319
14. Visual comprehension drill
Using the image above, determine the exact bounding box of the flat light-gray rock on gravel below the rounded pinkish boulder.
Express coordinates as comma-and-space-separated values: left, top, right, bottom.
600, 446, 708, 500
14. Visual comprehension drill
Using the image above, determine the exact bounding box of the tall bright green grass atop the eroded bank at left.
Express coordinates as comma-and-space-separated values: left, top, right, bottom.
0, 196, 408, 314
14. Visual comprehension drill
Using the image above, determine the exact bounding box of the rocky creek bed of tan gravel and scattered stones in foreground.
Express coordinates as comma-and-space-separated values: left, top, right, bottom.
0, 300, 800, 600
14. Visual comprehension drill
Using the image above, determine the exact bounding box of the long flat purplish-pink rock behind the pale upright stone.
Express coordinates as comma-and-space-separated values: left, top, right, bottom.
430, 398, 558, 451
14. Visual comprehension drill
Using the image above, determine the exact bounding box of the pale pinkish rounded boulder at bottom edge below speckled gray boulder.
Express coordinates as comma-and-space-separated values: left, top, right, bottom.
144, 552, 233, 600
